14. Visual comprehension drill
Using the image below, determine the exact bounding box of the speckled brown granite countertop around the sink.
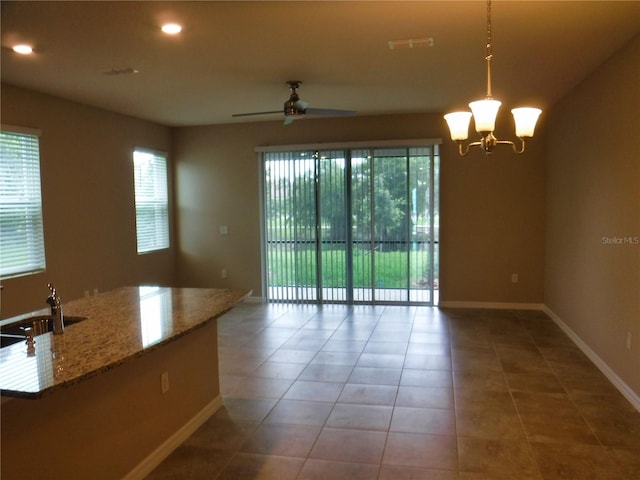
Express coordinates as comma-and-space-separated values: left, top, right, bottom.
0, 286, 250, 398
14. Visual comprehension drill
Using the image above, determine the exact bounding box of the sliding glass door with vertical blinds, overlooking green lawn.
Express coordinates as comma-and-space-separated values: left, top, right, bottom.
261, 144, 439, 305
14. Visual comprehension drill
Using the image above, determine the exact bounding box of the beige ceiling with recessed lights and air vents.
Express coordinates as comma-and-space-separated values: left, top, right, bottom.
0, 0, 640, 126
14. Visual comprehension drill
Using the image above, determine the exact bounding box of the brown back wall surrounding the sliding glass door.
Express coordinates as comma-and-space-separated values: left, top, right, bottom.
173, 113, 545, 304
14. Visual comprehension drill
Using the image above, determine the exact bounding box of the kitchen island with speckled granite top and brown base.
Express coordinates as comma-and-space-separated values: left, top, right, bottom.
0, 287, 249, 480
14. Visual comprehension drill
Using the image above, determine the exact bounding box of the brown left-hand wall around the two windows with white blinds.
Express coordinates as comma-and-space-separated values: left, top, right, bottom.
0, 84, 175, 318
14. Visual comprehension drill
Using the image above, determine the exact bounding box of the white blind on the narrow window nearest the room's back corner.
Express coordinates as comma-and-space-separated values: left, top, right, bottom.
133, 150, 169, 253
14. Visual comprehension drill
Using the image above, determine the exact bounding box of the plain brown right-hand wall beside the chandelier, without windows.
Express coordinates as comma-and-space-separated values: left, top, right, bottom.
545, 37, 640, 395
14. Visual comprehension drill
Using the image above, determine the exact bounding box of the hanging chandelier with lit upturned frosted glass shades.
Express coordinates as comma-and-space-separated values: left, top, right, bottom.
444, 0, 542, 156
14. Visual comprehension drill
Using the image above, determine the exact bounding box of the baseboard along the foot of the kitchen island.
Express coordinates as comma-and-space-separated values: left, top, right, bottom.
123, 395, 222, 480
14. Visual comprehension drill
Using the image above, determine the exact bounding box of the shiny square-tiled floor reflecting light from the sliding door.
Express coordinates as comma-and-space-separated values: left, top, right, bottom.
148, 304, 640, 480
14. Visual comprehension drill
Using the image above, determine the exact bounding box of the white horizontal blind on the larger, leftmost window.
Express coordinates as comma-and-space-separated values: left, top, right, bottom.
0, 126, 46, 278
